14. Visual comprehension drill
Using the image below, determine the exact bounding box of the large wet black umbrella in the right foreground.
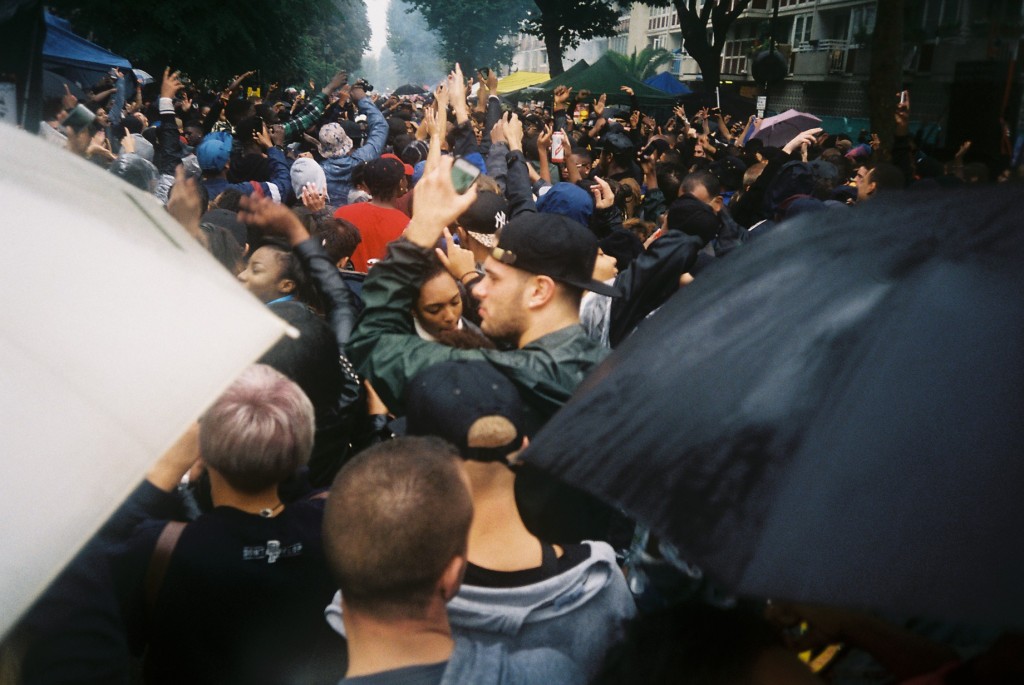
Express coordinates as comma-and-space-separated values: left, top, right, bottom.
524, 186, 1024, 626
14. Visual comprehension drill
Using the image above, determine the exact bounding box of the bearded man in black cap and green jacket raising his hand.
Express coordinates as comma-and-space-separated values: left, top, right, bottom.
347, 159, 616, 542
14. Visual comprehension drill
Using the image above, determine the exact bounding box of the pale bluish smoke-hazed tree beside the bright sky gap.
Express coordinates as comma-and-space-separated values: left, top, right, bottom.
387, 0, 447, 86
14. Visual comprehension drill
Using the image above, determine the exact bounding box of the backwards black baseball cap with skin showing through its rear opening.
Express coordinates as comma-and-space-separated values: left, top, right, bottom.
406, 359, 523, 462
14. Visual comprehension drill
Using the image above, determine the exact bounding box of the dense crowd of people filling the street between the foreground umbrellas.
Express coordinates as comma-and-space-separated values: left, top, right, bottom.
9, 58, 1022, 685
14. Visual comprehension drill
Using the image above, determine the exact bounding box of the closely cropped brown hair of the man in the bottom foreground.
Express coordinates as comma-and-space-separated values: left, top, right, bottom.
324, 437, 473, 618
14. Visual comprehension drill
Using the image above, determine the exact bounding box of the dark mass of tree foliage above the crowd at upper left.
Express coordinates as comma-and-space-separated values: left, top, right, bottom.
49, 0, 370, 87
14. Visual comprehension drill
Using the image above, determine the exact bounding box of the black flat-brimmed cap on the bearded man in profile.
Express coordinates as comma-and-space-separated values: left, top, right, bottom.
490, 212, 621, 297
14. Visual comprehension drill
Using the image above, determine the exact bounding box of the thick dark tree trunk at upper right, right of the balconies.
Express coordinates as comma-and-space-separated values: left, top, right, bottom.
867, 0, 904, 153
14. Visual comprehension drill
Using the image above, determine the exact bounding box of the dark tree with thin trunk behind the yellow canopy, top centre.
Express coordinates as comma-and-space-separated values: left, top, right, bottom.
521, 0, 622, 77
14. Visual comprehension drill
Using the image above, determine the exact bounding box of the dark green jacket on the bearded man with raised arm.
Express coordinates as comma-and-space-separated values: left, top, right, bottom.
346, 239, 608, 432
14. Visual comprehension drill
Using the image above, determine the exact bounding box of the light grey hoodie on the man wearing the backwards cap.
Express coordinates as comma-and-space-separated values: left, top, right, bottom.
325, 542, 636, 681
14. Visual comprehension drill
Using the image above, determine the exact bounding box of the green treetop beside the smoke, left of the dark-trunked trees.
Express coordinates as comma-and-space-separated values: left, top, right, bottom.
409, 0, 528, 69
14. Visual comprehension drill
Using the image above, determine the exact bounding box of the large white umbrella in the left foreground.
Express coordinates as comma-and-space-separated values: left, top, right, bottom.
0, 126, 288, 636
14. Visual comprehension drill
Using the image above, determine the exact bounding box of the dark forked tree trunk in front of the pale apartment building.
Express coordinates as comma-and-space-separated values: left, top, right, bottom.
645, 0, 753, 90
